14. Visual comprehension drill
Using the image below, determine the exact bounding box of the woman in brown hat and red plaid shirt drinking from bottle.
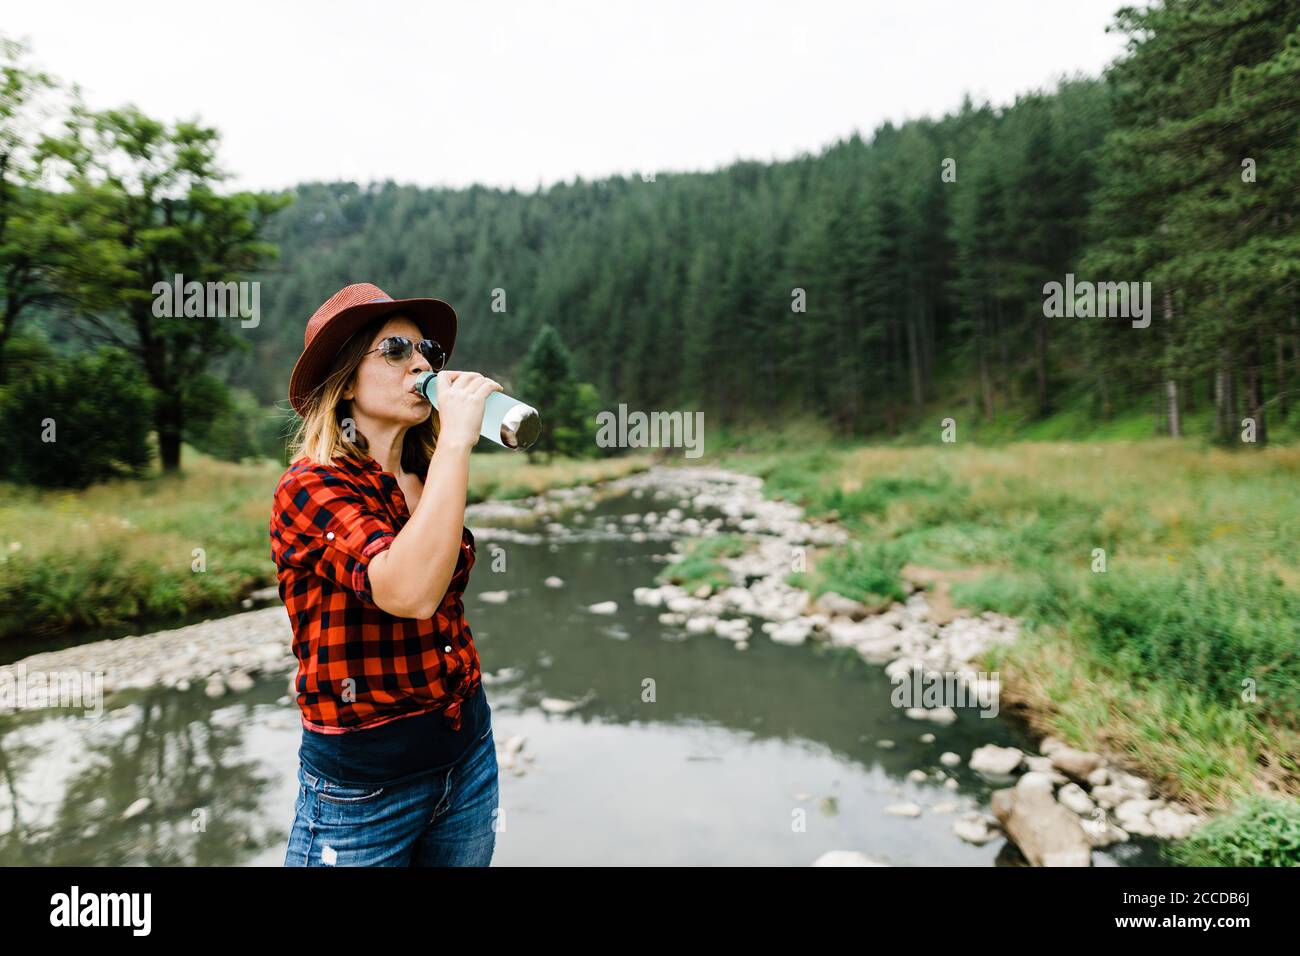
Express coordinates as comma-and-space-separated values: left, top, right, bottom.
270, 282, 501, 866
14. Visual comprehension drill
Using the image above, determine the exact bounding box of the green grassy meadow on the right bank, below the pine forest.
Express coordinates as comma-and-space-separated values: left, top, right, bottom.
706, 440, 1300, 810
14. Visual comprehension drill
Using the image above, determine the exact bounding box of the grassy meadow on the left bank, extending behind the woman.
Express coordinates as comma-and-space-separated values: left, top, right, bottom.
0, 446, 647, 639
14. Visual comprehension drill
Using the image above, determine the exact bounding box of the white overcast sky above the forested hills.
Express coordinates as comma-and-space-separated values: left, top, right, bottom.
0, 0, 1123, 191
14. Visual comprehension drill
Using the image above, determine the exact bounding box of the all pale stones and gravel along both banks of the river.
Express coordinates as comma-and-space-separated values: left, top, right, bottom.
0, 467, 1204, 865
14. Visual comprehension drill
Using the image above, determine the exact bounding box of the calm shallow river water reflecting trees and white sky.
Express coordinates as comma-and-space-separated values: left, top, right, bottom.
0, 478, 1160, 866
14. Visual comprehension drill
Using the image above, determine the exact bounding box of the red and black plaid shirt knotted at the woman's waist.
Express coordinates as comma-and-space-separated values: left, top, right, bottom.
270, 455, 482, 734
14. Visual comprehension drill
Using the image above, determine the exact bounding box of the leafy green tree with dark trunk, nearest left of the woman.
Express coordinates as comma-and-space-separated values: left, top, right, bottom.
43, 105, 286, 471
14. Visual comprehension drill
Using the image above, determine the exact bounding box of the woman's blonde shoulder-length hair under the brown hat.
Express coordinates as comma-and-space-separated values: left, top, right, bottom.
289, 312, 438, 476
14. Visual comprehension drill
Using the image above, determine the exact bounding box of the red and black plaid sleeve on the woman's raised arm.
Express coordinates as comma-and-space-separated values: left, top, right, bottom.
272, 470, 397, 609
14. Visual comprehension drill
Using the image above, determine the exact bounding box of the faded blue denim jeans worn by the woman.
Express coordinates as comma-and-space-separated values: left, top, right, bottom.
285, 723, 498, 866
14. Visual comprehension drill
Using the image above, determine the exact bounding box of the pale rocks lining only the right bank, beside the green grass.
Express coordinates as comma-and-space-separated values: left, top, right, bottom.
603, 468, 1205, 866
